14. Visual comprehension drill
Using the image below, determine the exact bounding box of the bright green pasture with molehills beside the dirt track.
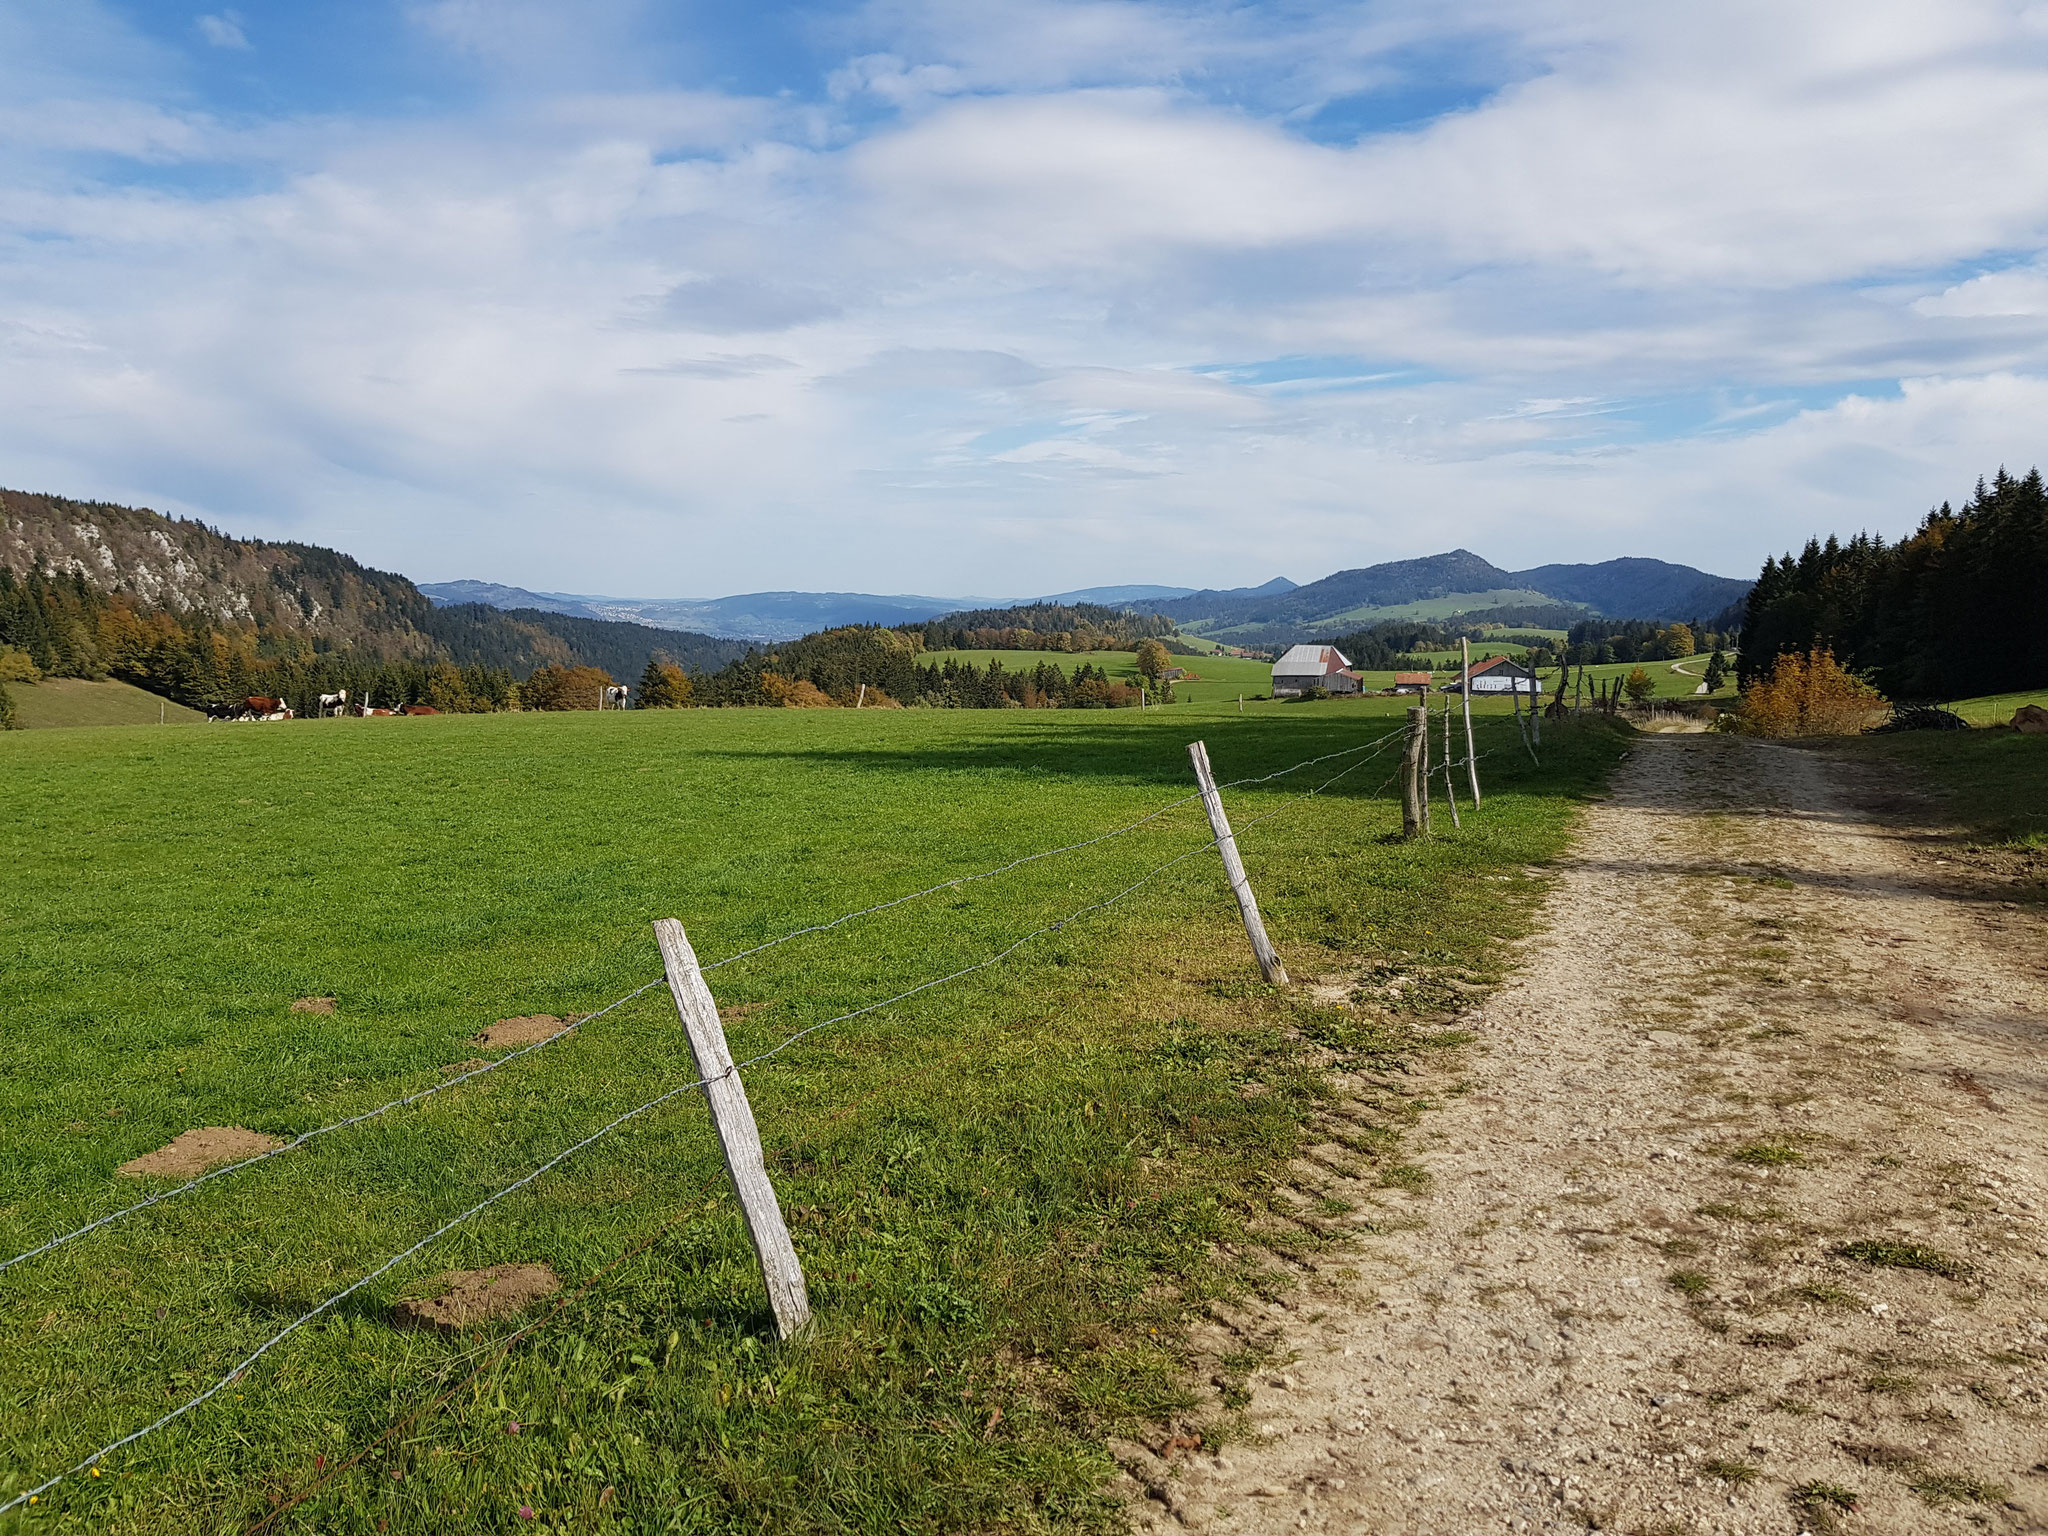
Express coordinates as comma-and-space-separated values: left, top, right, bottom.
0, 700, 1624, 1536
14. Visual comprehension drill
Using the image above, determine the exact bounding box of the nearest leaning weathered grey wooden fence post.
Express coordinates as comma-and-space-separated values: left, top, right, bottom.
653, 918, 811, 1339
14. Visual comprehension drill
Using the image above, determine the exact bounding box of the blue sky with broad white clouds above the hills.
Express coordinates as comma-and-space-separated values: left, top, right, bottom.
0, 0, 2048, 596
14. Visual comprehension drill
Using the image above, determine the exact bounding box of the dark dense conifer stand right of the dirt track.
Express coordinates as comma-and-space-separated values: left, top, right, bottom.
1737, 469, 2048, 700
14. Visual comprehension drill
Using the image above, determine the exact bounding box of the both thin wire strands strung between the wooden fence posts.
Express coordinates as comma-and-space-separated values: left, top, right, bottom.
0, 729, 1464, 1513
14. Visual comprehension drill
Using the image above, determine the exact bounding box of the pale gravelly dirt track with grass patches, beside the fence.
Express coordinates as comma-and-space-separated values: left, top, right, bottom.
1120, 735, 2048, 1536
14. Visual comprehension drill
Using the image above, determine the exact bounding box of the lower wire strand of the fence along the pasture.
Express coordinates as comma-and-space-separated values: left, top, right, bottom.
0, 731, 1425, 1513
